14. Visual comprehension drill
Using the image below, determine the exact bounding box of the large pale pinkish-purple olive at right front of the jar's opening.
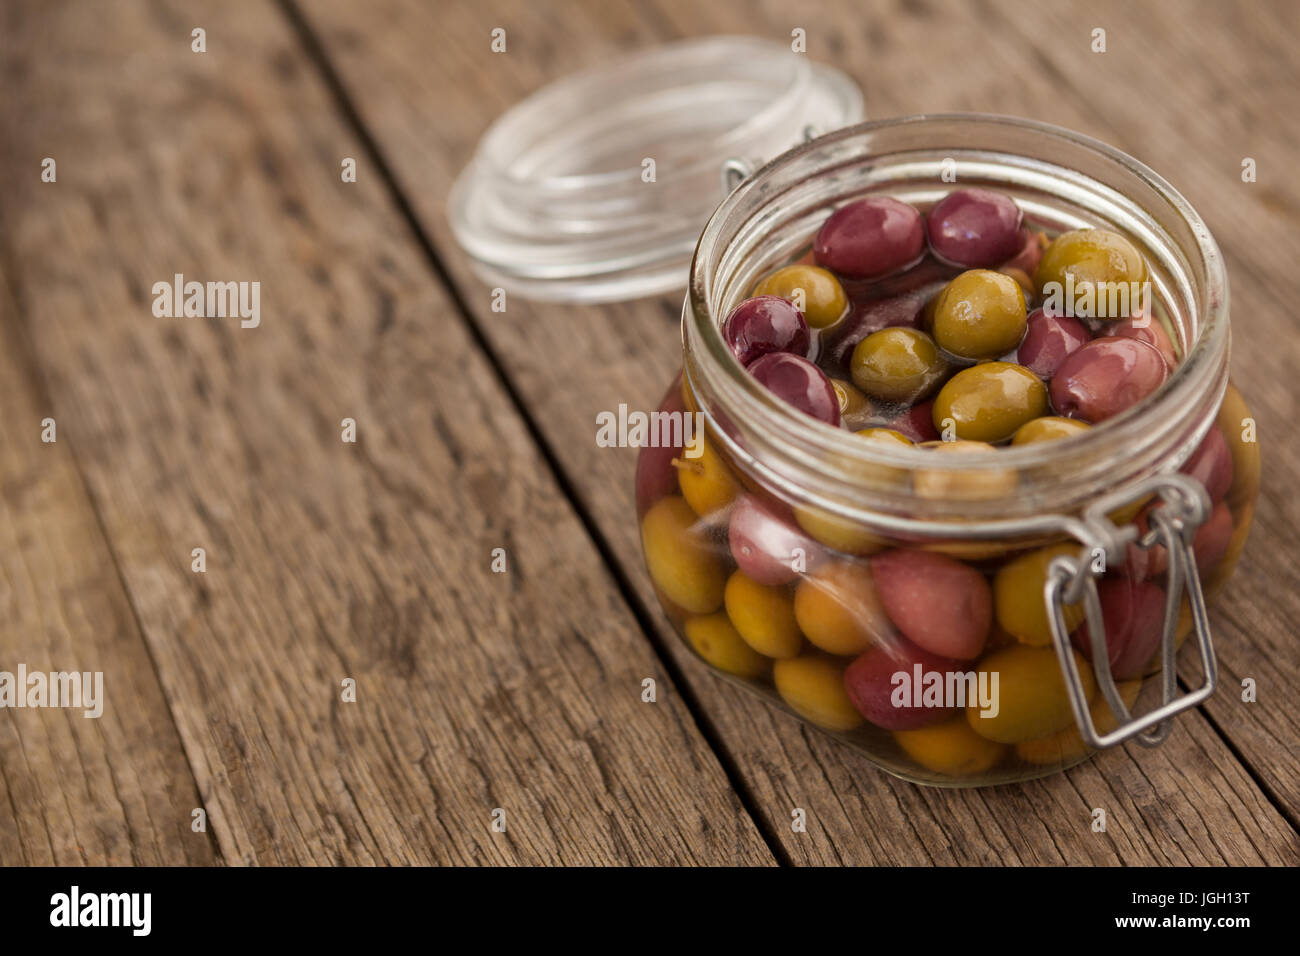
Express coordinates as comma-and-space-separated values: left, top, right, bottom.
1052, 336, 1169, 424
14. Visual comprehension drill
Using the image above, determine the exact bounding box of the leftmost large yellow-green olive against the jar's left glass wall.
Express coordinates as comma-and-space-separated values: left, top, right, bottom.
641, 494, 727, 614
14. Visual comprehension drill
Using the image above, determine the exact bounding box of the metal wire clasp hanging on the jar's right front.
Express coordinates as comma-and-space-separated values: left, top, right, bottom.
1043, 475, 1218, 750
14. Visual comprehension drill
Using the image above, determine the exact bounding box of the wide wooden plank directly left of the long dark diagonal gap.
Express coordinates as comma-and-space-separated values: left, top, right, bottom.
0, 3, 772, 864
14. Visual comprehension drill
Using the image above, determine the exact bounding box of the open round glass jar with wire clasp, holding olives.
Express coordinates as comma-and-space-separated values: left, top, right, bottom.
637, 114, 1260, 786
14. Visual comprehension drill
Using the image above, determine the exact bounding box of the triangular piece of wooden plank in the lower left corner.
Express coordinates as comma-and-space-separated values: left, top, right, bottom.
0, 278, 216, 866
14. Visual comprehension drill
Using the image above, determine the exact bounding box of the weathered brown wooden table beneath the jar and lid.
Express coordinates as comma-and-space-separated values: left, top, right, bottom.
0, 0, 1300, 865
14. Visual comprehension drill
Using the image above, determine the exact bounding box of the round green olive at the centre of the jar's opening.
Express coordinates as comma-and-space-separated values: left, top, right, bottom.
933, 269, 1028, 359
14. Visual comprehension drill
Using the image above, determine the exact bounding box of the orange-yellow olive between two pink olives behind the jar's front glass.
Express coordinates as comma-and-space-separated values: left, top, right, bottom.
794, 561, 893, 656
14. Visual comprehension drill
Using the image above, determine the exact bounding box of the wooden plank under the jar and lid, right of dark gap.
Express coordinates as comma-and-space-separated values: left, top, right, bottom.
299, 0, 1300, 864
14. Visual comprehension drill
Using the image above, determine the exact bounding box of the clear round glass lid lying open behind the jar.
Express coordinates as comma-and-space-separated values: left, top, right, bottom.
449, 36, 862, 302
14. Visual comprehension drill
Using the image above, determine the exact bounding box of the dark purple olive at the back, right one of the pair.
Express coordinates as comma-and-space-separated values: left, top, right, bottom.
926, 189, 1021, 269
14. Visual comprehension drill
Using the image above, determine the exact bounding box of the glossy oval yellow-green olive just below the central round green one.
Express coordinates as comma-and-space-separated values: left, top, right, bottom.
933, 362, 1048, 442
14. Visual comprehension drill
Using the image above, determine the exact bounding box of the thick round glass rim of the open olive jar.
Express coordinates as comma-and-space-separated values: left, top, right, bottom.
683, 113, 1230, 537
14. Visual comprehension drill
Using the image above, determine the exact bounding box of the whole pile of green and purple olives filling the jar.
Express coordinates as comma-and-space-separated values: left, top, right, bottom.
637, 189, 1258, 783
